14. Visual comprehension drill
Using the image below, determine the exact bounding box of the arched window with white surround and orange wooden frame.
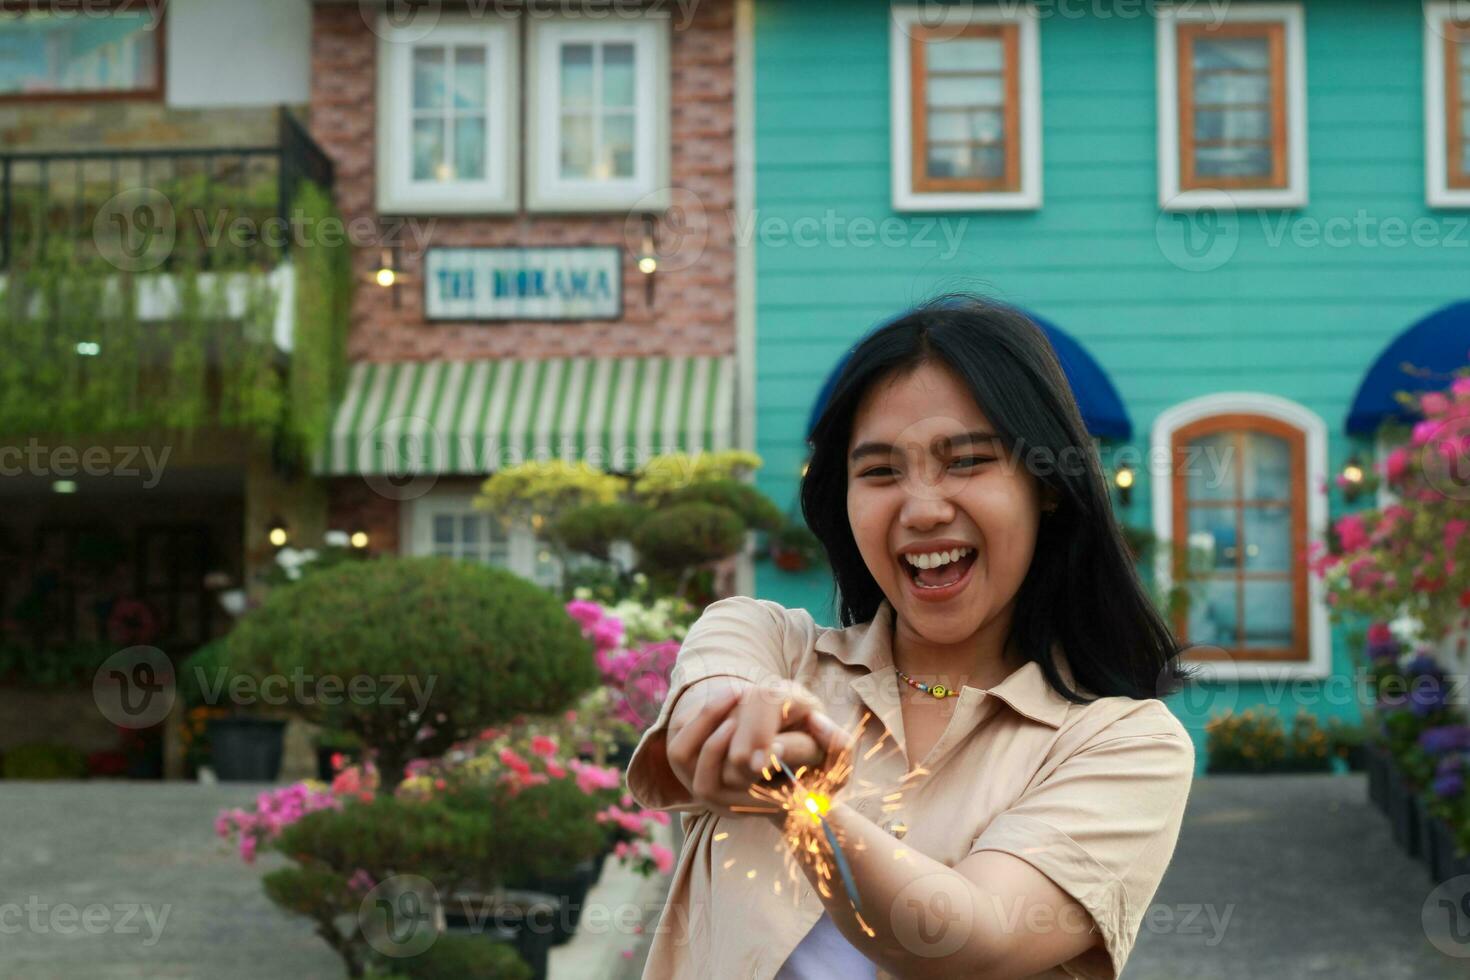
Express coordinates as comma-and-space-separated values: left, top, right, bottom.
1151, 392, 1332, 680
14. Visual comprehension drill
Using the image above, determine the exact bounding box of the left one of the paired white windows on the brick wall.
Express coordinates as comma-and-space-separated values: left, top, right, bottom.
378, 13, 519, 215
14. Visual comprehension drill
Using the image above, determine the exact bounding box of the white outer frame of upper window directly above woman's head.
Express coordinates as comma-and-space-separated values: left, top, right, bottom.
888, 3, 1042, 212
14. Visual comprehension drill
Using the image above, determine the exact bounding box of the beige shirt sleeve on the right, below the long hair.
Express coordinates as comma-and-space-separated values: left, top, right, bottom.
970, 716, 1195, 980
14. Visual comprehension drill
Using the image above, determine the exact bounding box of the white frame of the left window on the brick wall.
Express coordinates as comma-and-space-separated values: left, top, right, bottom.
376, 13, 520, 215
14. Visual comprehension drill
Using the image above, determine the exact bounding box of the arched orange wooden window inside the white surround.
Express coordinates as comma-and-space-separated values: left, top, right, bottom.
1170, 413, 1310, 663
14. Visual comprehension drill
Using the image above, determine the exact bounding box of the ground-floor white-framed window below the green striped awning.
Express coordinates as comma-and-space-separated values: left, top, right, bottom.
400, 488, 562, 589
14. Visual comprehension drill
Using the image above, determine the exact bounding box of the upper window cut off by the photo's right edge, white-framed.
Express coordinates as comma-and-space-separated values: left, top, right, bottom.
1424, 0, 1470, 207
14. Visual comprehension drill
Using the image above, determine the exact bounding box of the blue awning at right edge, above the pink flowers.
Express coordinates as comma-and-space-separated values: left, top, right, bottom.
1348, 301, 1470, 435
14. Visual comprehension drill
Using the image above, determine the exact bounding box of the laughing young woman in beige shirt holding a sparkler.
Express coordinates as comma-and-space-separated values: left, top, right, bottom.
628, 295, 1194, 980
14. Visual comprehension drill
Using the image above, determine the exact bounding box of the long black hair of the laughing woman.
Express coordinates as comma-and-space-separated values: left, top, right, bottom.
801, 292, 1191, 704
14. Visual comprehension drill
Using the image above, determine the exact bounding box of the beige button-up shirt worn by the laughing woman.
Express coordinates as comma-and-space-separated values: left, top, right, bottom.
628, 597, 1195, 980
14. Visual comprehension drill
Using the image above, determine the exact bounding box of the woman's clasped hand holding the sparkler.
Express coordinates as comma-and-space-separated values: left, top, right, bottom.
666, 677, 847, 817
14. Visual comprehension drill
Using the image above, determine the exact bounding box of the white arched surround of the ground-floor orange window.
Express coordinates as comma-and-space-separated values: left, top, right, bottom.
1150, 391, 1332, 680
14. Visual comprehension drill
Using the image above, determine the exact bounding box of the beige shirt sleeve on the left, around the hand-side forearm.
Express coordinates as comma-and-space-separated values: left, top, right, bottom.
628, 595, 792, 811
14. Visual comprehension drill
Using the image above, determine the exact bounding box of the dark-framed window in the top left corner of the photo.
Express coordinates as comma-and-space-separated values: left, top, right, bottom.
0, 0, 165, 101
